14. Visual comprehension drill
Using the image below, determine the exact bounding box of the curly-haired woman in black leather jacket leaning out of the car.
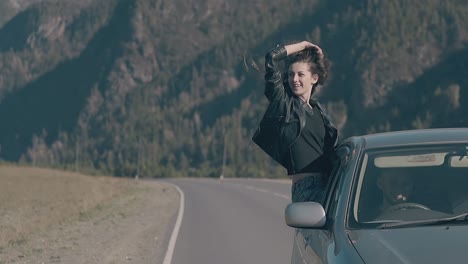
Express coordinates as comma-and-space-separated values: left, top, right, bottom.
252, 41, 338, 202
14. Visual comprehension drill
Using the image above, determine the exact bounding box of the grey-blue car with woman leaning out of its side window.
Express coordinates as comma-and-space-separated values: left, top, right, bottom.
284, 128, 468, 264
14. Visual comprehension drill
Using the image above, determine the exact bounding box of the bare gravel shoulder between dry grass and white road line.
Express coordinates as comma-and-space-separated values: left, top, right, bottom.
0, 180, 179, 264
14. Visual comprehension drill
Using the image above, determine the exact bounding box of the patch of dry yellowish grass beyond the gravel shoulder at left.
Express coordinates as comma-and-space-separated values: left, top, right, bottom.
0, 166, 139, 249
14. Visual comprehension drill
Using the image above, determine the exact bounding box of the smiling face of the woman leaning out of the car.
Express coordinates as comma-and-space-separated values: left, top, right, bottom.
288, 62, 318, 102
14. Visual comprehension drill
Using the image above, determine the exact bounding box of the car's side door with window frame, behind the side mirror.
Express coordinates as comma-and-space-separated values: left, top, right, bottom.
291, 146, 351, 264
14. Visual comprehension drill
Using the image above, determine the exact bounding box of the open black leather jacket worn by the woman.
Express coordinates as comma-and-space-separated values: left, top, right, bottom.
252, 46, 338, 175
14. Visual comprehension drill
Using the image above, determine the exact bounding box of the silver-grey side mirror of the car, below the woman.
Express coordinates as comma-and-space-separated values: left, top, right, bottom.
284, 202, 327, 228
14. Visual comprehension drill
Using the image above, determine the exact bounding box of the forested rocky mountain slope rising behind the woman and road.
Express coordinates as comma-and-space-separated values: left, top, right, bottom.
0, 0, 468, 177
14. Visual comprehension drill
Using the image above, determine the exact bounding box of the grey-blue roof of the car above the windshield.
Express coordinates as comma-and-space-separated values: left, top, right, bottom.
352, 128, 468, 149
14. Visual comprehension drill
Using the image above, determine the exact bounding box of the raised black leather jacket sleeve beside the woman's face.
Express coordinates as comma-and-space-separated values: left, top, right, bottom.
264, 46, 287, 102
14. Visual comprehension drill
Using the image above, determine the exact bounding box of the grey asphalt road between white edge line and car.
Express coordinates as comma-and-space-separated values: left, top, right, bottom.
165, 179, 294, 264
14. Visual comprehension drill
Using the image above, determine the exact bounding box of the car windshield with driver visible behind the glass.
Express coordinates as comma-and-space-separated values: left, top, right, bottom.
350, 145, 468, 227
